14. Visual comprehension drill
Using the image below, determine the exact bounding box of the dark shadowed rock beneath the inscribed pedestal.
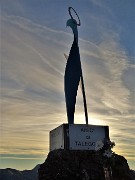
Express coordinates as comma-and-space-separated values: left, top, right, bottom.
38, 150, 133, 180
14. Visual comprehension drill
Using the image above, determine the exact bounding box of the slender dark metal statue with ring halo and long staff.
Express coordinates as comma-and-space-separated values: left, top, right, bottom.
64, 7, 88, 124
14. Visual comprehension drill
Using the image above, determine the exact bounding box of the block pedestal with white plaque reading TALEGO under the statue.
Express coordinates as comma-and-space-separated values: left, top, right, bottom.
50, 124, 109, 151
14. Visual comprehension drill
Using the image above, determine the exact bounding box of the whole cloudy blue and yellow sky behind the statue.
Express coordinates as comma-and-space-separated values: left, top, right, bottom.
0, 0, 135, 170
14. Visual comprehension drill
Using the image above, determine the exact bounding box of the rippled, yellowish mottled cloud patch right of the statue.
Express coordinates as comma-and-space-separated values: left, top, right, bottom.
79, 34, 134, 113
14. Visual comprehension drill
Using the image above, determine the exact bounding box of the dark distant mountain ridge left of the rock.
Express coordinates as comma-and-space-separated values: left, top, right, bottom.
0, 165, 40, 180
